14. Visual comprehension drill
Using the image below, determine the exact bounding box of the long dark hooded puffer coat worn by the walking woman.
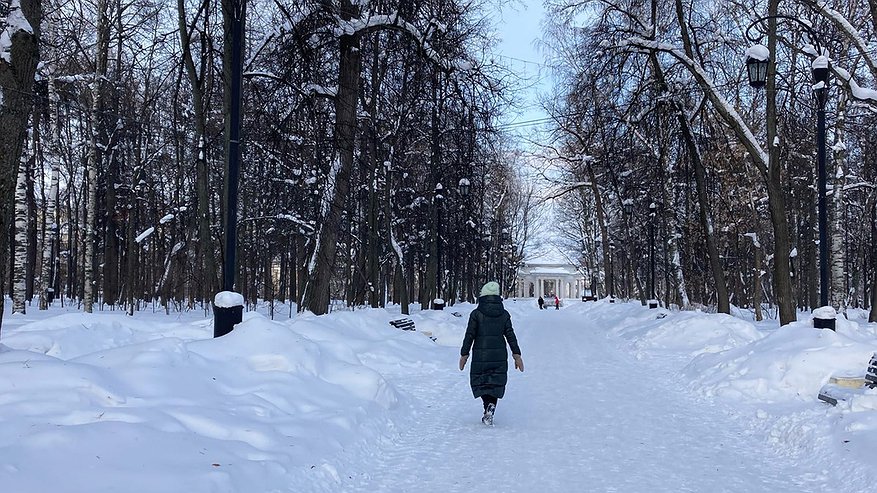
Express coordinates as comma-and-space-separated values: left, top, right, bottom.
460, 296, 521, 399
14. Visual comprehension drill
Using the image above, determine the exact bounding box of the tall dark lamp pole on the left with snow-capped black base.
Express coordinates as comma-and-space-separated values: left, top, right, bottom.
213, 0, 247, 337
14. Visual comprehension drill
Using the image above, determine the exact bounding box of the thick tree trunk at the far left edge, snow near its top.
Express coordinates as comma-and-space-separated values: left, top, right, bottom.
0, 0, 42, 334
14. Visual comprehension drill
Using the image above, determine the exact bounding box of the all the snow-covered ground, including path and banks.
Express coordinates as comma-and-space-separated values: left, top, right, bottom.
0, 300, 877, 493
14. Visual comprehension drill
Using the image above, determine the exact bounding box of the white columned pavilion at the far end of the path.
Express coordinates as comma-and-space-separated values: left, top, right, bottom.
515, 263, 591, 298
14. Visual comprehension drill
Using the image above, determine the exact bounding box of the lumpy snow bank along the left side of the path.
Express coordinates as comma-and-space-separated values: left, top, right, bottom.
0, 310, 456, 493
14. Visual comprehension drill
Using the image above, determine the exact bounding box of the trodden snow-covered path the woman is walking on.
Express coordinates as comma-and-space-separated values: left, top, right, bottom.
336, 310, 842, 493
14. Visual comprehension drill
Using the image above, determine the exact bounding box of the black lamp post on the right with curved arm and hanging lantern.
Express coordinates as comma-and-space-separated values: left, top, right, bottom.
746, 15, 835, 330
